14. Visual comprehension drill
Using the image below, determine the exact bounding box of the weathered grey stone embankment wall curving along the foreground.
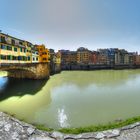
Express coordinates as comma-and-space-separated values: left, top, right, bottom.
0, 112, 140, 140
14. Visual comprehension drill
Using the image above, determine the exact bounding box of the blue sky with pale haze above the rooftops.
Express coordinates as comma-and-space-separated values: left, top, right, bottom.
0, 0, 140, 52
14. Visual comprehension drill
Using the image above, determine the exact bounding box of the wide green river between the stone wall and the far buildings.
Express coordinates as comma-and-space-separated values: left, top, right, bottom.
0, 70, 140, 129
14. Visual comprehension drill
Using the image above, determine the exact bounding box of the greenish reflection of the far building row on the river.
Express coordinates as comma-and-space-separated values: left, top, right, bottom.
52, 70, 140, 87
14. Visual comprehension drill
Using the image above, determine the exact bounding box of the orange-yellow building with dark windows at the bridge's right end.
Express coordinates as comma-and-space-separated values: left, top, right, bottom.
35, 45, 50, 63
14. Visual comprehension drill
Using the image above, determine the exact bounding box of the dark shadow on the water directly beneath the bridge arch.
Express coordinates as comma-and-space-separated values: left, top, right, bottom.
0, 77, 47, 101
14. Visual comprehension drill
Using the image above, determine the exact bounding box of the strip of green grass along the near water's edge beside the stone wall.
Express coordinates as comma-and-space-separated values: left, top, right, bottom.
35, 116, 140, 134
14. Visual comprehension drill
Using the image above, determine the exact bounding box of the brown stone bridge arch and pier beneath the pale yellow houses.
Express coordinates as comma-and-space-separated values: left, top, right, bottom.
0, 63, 50, 79
